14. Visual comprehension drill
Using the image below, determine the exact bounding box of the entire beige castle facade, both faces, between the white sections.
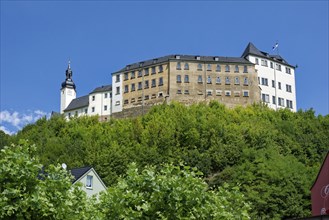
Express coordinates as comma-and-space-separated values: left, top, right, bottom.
115, 59, 260, 117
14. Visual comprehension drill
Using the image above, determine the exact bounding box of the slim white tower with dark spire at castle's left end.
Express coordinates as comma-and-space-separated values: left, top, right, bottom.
60, 61, 76, 114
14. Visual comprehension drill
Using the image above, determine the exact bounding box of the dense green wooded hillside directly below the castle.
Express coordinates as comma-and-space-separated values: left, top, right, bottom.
2, 102, 329, 219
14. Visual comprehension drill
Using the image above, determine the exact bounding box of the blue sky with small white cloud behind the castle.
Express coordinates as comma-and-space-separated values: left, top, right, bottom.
0, 1, 329, 133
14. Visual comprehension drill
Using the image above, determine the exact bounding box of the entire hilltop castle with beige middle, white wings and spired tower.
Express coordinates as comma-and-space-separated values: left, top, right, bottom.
61, 43, 297, 120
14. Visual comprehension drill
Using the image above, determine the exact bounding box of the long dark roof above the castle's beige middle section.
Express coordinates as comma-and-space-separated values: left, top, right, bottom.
112, 54, 252, 74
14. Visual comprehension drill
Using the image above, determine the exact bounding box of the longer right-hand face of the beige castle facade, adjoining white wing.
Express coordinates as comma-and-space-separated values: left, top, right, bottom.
168, 60, 260, 107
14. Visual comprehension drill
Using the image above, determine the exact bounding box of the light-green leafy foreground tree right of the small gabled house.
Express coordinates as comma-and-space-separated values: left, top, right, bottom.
99, 163, 249, 219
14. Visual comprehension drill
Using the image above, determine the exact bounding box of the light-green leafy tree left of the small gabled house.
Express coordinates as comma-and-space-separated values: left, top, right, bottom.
0, 141, 97, 219
